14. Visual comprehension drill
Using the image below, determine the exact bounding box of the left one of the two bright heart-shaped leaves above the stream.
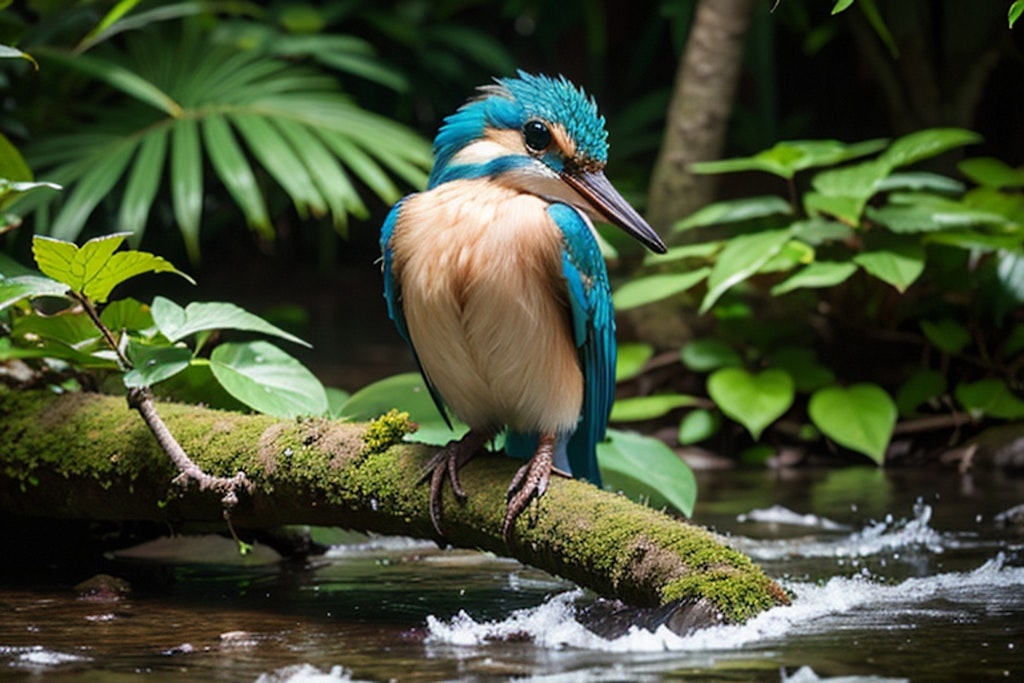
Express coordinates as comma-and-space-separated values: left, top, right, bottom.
708, 368, 795, 439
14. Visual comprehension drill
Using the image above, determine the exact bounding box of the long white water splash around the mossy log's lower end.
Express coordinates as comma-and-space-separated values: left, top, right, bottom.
427, 554, 1024, 652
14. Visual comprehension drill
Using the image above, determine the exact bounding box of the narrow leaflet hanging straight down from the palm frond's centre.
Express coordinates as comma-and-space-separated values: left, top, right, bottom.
171, 118, 203, 262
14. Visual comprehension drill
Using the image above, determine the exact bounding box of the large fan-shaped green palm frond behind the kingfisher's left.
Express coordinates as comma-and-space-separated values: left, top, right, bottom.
27, 28, 431, 258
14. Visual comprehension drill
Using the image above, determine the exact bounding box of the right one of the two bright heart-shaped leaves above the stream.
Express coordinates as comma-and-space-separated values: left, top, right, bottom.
807, 384, 896, 465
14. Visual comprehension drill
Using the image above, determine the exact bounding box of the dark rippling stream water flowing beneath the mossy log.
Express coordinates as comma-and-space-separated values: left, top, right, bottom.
0, 468, 1024, 683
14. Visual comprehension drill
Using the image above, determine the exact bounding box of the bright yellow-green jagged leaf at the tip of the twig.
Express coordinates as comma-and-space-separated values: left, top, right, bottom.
32, 232, 195, 303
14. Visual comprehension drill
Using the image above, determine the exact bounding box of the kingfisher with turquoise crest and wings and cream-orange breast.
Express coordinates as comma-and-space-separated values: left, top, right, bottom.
380, 71, 666, 543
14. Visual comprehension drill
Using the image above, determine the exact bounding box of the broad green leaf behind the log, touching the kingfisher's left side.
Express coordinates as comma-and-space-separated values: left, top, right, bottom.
340, 373, 469, 445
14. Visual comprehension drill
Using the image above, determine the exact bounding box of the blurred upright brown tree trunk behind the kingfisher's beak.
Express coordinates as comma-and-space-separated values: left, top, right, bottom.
647, 0, 755, 234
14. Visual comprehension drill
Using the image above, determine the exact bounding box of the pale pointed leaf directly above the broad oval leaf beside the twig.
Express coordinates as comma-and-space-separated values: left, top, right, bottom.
153, 296, 309, 346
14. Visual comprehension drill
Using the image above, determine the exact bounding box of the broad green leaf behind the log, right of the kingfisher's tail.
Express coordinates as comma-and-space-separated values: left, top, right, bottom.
597, 429, 697, 516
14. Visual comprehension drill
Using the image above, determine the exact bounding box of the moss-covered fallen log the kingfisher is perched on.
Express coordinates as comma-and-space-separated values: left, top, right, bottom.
0, 388, 788, 628
